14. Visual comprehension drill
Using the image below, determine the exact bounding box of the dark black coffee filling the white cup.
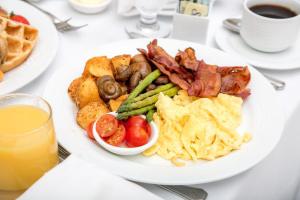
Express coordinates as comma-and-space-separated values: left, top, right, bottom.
250, 4, 297, 19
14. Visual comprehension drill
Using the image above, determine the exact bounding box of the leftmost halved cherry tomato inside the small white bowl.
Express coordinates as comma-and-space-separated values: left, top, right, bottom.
96, 114, 118, 138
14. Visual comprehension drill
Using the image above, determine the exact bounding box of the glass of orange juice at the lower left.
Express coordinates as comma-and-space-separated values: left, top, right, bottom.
0, 94, 59, 195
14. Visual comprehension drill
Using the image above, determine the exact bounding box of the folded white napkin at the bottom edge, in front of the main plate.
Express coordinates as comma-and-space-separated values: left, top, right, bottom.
18, 155, 161, 200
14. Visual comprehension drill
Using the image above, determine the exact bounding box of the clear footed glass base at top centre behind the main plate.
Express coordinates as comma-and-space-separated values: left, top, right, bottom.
125, 0, 170, 38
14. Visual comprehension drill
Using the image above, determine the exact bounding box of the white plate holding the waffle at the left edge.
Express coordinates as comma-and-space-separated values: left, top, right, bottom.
0, 0, 58, 95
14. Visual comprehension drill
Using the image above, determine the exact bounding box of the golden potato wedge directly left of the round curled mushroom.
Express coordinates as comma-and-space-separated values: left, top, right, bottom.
75, 77, 102, 108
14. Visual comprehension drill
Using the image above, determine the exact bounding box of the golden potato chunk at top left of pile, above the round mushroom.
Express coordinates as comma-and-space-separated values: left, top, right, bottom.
83, 56, 113, 77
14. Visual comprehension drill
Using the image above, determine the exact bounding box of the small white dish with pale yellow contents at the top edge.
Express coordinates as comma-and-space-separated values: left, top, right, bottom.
68, 0, 111, 14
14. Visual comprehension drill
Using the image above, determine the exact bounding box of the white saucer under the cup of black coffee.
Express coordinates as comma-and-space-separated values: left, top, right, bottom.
215, 27, 300, 70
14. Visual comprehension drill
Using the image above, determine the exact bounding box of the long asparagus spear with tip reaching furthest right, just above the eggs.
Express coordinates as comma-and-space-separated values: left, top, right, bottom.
118, 87, 178, 113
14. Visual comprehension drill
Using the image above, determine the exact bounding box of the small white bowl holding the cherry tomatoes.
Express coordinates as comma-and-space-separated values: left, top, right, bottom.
93, 112, 158, 156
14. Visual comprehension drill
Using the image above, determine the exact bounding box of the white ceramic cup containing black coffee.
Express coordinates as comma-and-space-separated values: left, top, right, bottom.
240, 0, 300, 52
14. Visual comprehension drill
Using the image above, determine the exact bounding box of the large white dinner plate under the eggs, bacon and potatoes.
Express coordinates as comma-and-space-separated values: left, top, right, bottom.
44, 39, 284, 185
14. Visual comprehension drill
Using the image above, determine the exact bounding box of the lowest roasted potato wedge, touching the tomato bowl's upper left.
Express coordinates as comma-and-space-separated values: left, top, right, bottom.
76, 101, 110, 129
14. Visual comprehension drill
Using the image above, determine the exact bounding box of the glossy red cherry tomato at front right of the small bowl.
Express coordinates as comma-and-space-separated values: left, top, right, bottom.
126, 126, 149, 147
